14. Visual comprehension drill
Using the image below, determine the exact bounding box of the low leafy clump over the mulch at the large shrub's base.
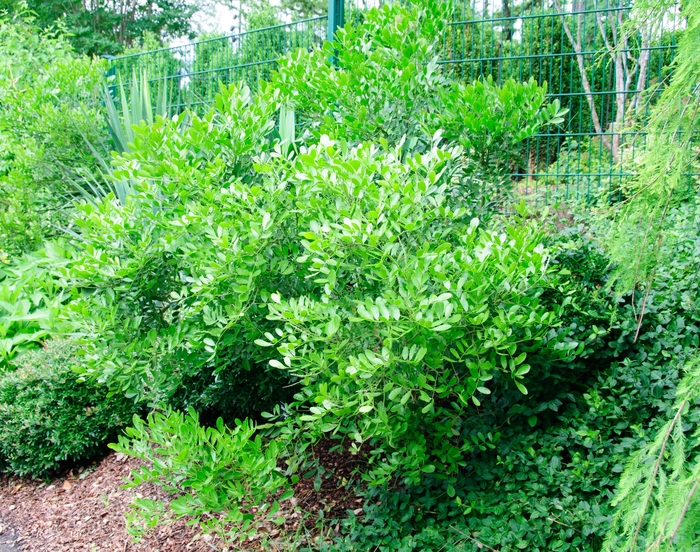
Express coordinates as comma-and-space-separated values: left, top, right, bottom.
110, 409, 292, 542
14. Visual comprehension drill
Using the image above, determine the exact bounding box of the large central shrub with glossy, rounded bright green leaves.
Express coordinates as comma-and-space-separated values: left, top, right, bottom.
60, 2, 577, 540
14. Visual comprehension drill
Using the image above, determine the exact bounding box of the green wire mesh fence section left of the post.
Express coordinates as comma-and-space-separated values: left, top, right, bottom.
112, 16, 328, 111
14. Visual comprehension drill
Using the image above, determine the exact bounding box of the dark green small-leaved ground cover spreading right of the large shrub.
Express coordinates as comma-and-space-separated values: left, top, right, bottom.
454, 201, 700, 550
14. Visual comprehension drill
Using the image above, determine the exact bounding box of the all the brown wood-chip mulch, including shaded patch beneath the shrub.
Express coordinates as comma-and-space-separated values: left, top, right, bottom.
0, 441, 363, 552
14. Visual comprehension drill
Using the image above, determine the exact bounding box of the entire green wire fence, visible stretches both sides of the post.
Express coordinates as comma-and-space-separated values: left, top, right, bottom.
106, 0, 684, 201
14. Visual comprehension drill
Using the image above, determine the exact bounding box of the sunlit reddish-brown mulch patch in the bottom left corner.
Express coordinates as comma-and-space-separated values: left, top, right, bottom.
0, 454, 221, 552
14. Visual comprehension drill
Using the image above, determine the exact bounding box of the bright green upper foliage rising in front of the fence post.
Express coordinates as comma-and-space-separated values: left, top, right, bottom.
272, 2, 565, 207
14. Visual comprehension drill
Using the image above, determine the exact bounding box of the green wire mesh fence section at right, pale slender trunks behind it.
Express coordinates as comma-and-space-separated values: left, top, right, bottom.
442, 0, 683, 201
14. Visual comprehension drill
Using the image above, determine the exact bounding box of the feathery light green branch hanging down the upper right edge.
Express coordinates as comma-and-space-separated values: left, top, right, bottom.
610, 0, 700, 300
